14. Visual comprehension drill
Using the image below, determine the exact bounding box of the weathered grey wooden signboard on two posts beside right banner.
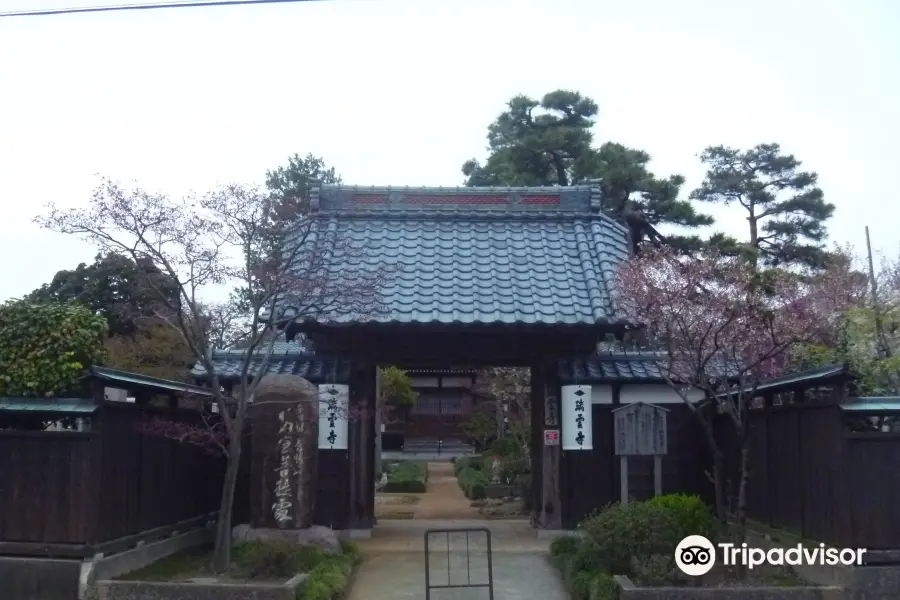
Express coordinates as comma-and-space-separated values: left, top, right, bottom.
613, 402, 669, 504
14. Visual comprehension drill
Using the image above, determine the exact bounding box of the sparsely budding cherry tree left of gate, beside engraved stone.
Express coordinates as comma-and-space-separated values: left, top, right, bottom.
35, 179, 390, 573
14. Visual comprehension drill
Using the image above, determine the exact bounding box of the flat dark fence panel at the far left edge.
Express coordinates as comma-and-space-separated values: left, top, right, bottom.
0, 431, 95, 544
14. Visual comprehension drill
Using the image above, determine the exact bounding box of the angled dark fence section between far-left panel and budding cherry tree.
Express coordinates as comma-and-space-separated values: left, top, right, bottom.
94, 405, 225, 543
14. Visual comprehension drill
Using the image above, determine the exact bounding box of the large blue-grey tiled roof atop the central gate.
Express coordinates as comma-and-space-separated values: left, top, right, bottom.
282, 186, 630, 326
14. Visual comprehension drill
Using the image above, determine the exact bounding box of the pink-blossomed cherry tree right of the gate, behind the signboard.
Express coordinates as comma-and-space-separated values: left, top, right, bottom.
616, 247, 865, 539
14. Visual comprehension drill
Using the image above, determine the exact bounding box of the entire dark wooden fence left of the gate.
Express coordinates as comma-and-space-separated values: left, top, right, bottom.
0, 403, 225, 557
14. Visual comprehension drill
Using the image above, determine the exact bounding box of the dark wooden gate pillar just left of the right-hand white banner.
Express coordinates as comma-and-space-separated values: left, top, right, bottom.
532, 364, 562, 529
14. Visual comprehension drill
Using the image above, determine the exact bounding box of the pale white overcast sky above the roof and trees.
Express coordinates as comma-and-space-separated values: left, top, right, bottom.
0, 0, 900, 300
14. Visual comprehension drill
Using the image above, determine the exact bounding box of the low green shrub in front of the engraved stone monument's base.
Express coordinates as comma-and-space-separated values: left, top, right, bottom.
232, 540, 328, 579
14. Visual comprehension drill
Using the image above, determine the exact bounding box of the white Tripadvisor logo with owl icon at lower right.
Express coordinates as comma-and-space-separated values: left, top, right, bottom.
675, 535, 866, 577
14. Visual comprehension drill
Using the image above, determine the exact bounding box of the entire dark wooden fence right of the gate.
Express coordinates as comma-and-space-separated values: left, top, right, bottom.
720, 402, 900, 550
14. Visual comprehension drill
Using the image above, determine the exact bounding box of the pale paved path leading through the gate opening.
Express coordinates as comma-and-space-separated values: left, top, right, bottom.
347, 463, 568, 600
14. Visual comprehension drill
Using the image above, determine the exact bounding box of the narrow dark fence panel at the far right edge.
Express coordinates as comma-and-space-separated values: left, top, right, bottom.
842, 434, 900, 550
